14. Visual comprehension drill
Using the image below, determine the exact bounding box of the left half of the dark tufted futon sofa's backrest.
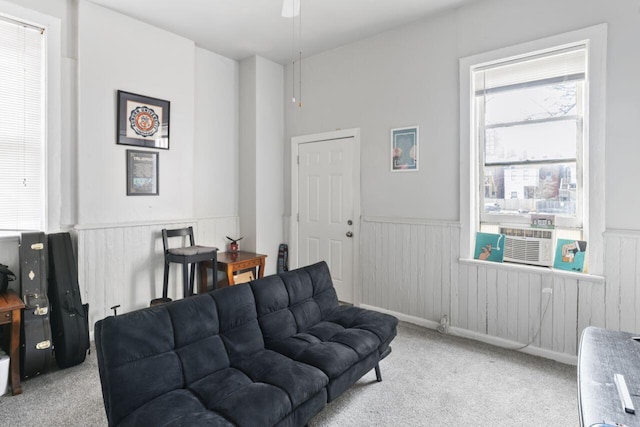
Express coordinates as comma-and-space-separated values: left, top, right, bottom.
96, 285, 264, 425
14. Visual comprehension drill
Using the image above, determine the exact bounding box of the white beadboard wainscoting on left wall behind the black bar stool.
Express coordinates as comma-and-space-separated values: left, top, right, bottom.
75, 217, 239, 331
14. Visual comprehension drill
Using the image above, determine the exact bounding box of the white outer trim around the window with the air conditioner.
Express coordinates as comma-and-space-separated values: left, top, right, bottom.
460, 24, 607, 275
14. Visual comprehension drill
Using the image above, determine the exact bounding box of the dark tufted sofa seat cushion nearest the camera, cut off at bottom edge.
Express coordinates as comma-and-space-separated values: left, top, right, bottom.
119, 389, 233, 427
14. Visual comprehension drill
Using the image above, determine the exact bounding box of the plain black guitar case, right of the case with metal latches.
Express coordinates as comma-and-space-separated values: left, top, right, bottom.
49, 233, 89, 368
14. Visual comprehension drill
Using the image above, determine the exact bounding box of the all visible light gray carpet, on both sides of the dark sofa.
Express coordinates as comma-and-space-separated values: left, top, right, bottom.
0, 324, 578, 427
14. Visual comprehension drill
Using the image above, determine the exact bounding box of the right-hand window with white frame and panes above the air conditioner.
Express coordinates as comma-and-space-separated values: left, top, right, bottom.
460, 24, 607, 275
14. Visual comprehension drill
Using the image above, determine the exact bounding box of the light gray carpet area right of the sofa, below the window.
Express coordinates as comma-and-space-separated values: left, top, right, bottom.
310, 324, 579, 427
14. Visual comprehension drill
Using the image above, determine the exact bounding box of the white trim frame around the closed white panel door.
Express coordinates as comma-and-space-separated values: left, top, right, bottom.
289, 128, 361, 305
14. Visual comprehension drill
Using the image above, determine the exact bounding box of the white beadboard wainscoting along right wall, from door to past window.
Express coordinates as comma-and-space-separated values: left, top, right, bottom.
360, 217, 612, 361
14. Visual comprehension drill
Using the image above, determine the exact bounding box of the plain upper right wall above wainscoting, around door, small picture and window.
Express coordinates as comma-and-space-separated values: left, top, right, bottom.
285, 0, 640, 229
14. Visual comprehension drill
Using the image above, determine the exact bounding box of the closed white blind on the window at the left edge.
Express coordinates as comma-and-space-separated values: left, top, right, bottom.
0, 19, 45, 230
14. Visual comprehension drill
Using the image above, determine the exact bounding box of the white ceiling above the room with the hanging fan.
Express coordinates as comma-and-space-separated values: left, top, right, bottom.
91, 0, 478, 64
